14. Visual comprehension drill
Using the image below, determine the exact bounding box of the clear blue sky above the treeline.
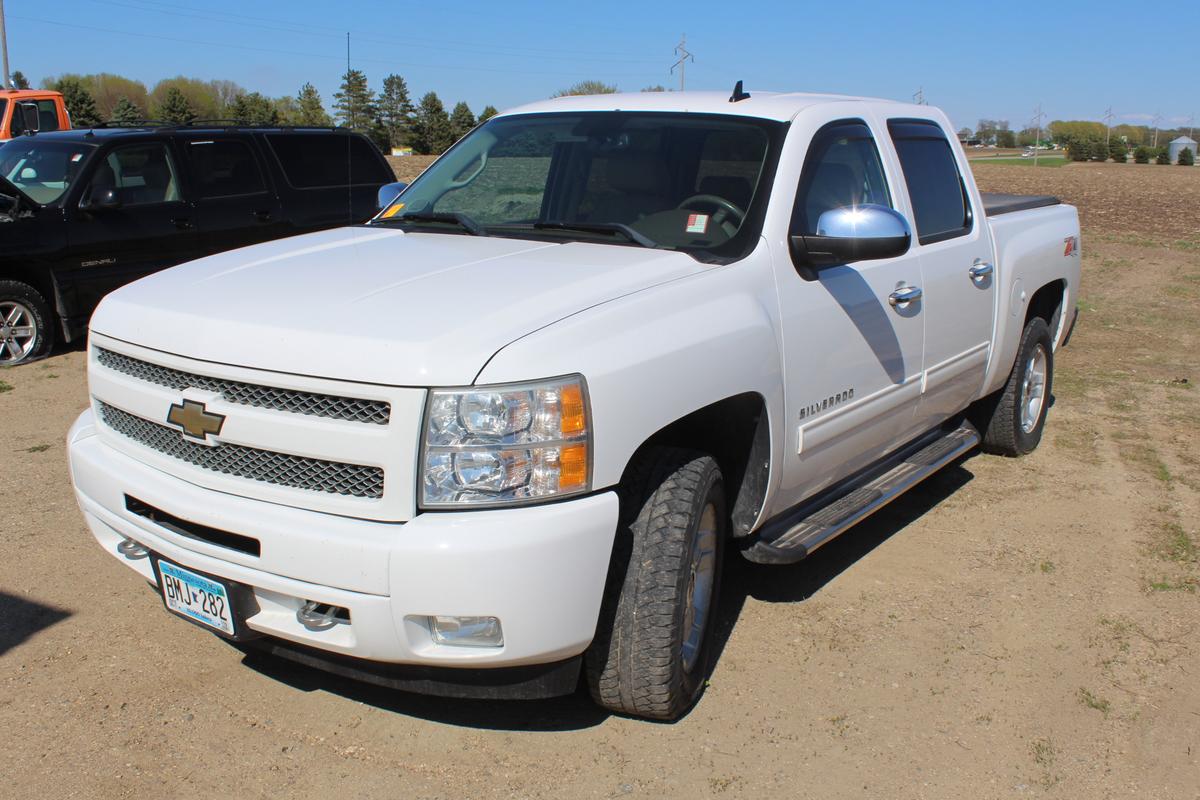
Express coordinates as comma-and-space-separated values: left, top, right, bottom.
5, 0, 1200, 128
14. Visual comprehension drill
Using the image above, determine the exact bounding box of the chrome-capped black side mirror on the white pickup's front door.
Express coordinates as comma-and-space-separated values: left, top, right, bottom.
790, 205, 912, 269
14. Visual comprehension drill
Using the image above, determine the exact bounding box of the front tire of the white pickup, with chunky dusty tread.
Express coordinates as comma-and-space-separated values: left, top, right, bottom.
586, 447, 727, 720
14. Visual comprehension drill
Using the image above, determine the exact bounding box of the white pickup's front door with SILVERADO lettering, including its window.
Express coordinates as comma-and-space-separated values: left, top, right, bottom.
776, 119, 924, 503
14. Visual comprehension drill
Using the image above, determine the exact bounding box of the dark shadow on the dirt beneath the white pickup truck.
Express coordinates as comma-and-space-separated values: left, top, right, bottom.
234, 464, 974, 732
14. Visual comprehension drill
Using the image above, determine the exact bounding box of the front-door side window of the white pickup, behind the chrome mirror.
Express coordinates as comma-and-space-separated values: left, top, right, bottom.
792, 120, 892, 235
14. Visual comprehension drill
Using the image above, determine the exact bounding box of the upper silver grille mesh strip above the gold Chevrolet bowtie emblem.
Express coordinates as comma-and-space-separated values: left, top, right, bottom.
96, 347, 391, 425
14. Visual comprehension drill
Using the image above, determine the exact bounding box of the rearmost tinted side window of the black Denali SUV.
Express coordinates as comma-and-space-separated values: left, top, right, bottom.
266, 134, 395, 188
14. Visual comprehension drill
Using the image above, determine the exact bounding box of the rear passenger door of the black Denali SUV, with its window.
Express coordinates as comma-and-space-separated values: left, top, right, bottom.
178, 134, 289, 255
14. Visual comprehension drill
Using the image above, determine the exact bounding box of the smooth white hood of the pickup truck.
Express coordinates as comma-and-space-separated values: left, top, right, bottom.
91, 227, 710, 386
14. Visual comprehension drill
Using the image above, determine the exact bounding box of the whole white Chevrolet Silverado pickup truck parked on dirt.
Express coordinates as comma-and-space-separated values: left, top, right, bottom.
68, 84, 1080, 718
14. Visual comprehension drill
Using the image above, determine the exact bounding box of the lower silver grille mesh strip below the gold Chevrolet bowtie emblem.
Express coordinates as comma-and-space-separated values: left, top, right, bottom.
96, 401, 383, 499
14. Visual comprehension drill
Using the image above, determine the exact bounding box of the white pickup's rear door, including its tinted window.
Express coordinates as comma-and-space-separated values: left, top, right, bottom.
888, 119, 995, 427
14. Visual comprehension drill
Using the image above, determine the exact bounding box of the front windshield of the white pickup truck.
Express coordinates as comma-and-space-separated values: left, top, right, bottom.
376, 112, 782, 254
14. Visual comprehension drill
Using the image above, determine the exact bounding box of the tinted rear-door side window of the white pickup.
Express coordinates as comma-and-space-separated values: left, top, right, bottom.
888, 120, 971, 245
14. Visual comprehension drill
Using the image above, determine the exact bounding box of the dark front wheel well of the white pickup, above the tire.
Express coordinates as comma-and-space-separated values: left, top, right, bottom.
625, 392, 770, 536
